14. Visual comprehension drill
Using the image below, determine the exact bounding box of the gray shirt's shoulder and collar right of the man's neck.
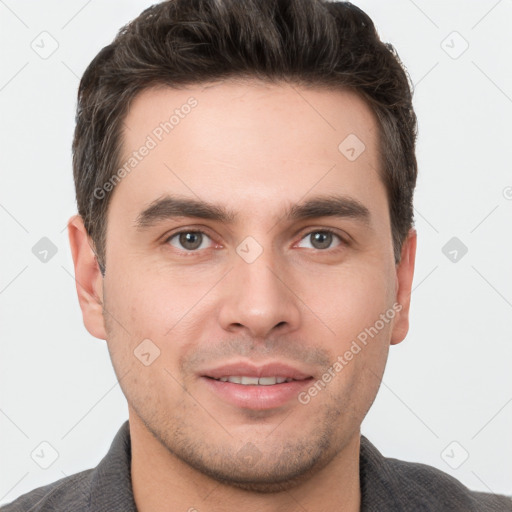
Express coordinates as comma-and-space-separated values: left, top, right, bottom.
361, 436, 512, 512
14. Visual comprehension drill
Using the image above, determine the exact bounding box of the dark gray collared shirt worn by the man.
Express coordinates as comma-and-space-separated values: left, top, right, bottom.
0, 421, 512, 512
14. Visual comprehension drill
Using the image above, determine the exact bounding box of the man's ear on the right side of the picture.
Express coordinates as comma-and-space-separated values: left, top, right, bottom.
391, 228, 417, 345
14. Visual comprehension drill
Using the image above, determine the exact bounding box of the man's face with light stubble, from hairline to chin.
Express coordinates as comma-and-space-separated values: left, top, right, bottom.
82, 81, 412, 490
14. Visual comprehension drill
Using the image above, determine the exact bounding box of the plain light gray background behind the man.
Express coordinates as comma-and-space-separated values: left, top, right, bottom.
0, 0, 512, 503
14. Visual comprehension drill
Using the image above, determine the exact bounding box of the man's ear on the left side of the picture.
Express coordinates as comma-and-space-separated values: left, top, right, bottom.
68, 215, 107, 340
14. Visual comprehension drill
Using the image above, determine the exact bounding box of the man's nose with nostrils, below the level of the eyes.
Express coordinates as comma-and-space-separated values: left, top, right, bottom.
219, 242, 301, 340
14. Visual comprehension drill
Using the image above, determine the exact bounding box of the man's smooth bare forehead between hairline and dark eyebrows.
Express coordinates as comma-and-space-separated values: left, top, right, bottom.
111, 80, 386, 231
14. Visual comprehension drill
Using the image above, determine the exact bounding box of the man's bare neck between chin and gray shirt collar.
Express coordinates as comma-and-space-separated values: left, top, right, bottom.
130, 411, 361, 512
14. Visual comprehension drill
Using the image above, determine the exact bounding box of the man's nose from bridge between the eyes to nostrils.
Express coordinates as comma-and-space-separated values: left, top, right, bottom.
221, 237, 300, 338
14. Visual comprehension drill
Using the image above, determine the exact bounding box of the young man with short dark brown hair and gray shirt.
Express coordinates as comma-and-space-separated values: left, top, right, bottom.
2, 0, 512, 512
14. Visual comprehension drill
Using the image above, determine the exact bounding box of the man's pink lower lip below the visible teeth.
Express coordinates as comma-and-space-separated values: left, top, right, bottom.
201, 377, 313, 410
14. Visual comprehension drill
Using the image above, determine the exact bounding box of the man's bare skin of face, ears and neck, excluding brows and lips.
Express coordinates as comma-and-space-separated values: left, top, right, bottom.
68, 80, 416, 512
